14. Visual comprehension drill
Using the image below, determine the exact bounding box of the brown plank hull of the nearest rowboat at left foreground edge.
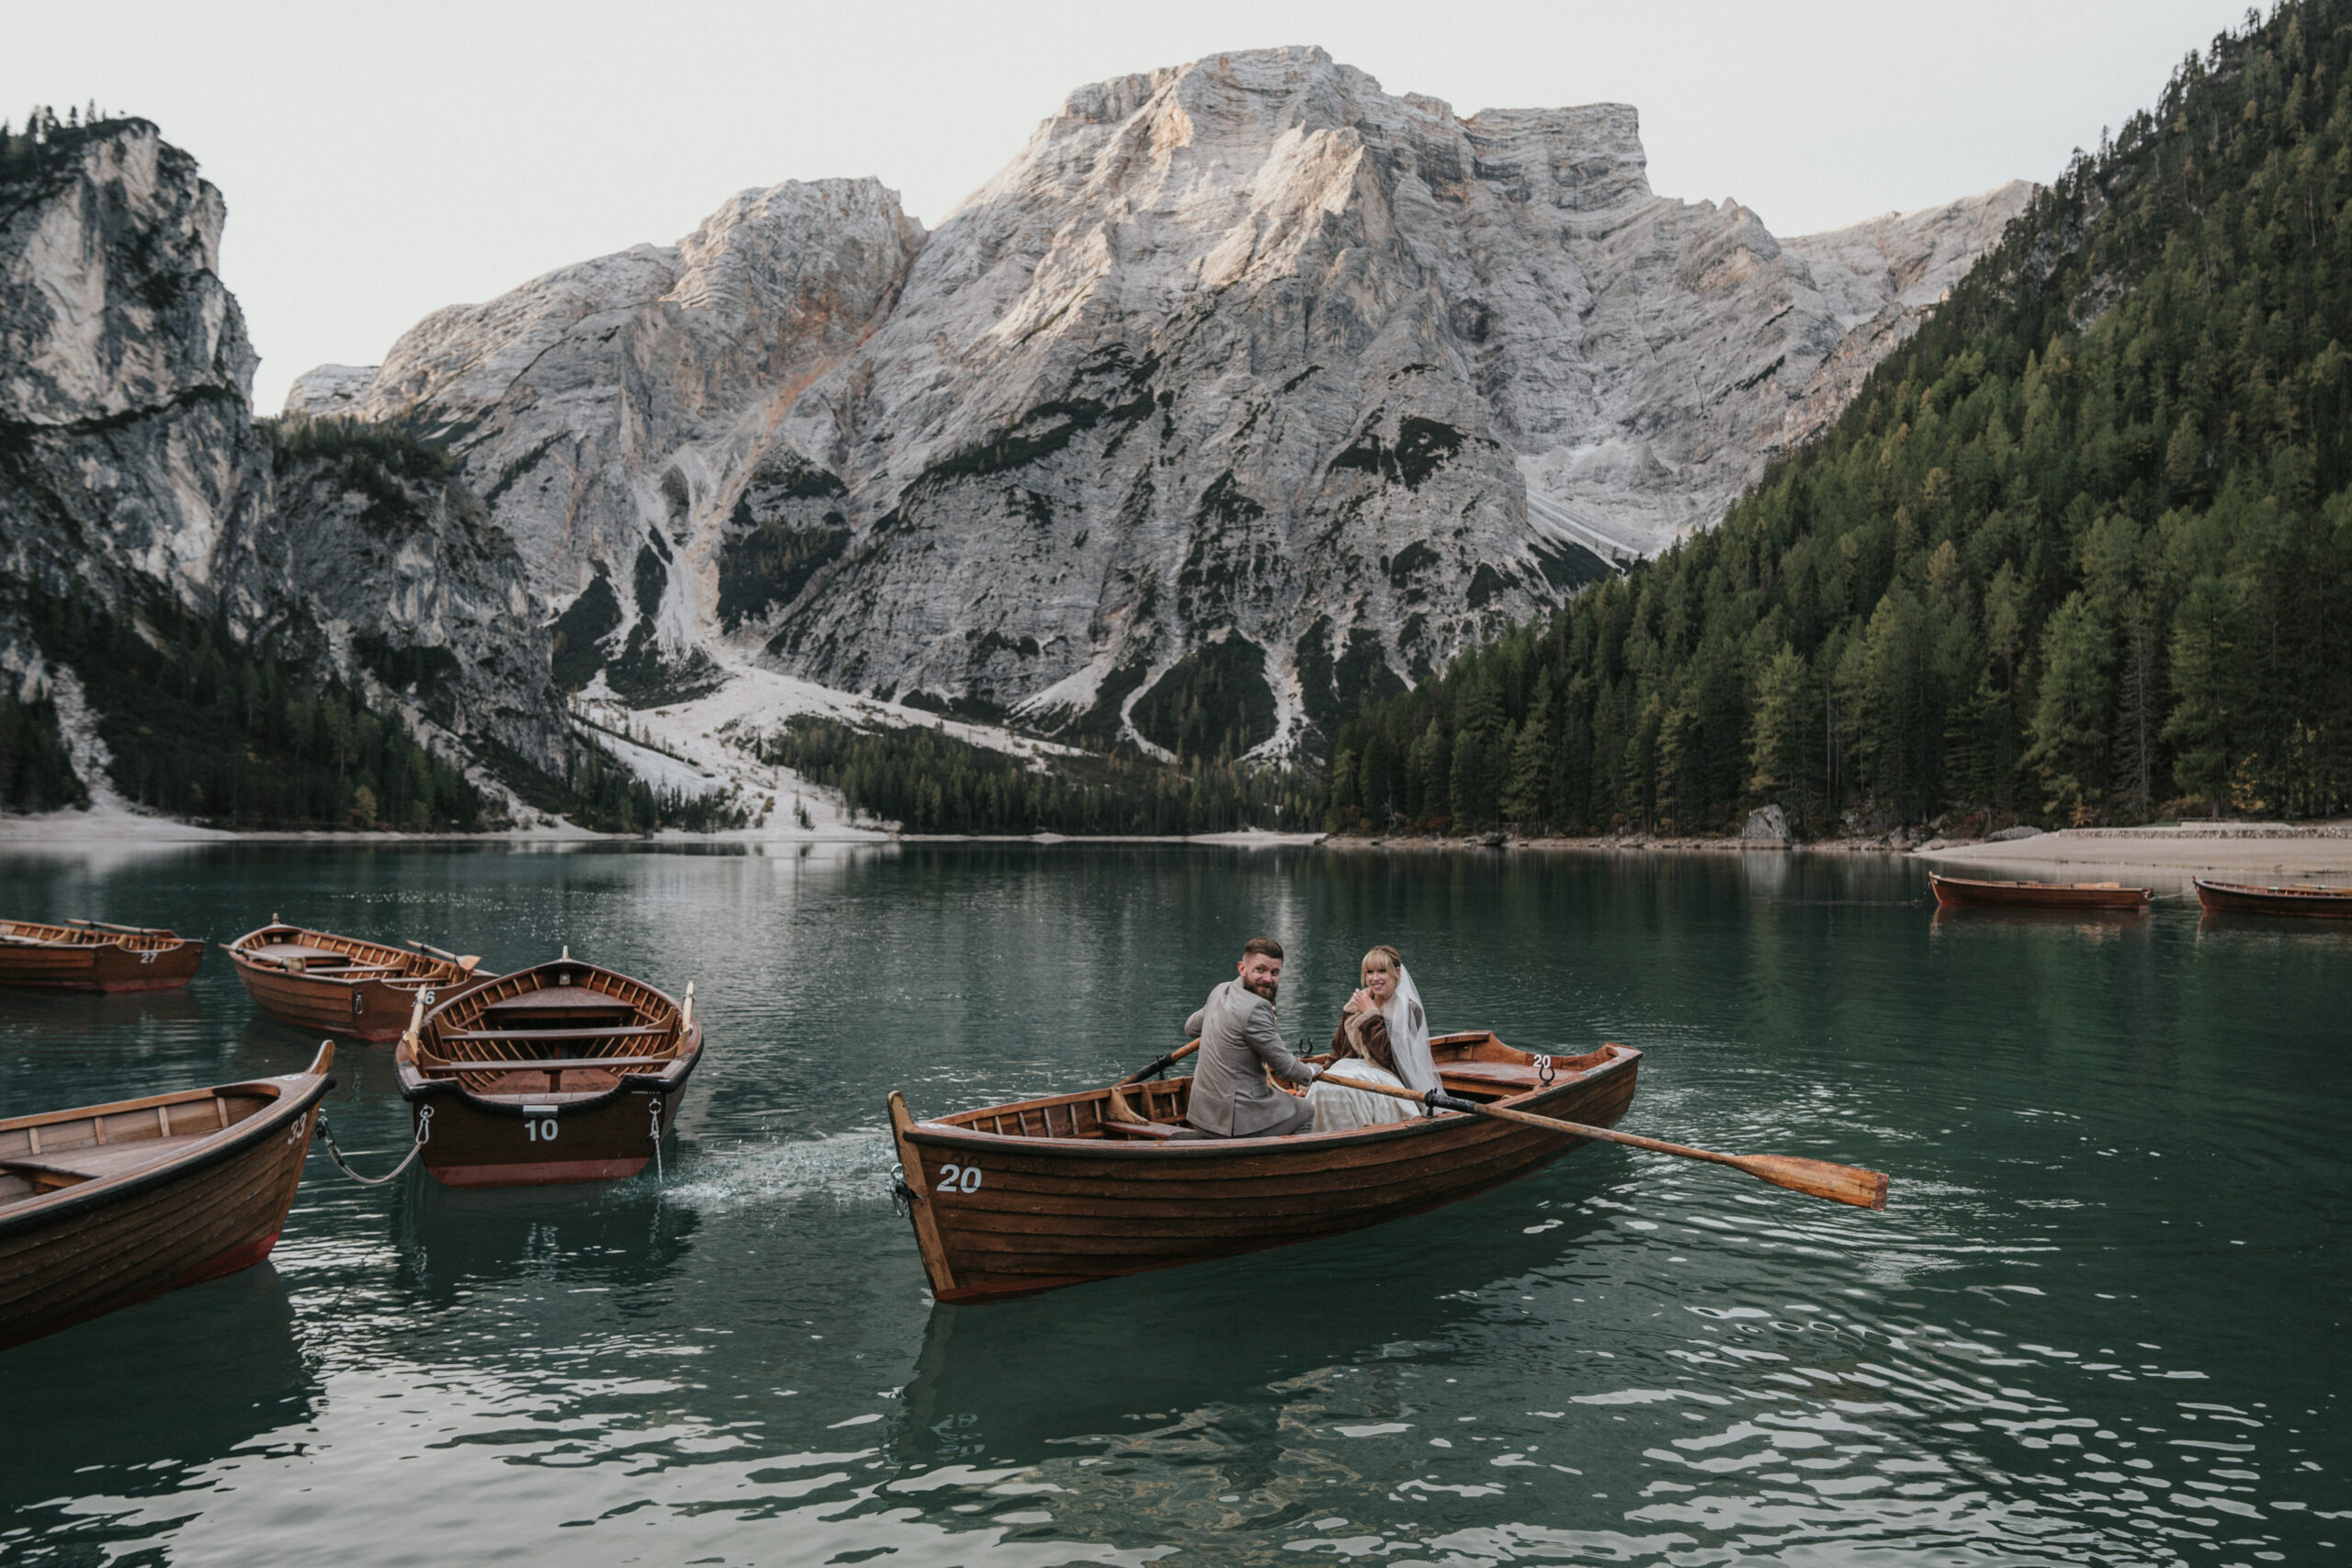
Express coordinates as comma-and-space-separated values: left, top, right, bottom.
0, 1054, 334, 1347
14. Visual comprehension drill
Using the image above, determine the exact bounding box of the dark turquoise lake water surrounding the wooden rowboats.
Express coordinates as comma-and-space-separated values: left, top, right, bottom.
0, 844, 2352, 1568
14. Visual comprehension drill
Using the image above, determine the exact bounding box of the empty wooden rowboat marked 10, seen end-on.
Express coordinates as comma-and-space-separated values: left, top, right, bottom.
393, 952, 703, 1187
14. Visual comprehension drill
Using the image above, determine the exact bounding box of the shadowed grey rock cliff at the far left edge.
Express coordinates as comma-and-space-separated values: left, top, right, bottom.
0, 120, 564, 783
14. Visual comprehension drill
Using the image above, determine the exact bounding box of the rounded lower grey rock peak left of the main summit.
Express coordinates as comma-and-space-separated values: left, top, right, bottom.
303, 179, 924, 694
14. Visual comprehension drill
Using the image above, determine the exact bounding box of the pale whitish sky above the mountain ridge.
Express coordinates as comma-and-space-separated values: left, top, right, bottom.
14, 0, 2246, 413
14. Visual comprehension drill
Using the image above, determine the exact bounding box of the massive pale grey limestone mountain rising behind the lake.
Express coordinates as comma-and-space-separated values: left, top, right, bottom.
289, 50, 2025, 755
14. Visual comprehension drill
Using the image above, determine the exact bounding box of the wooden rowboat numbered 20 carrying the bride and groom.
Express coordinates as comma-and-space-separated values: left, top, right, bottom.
889, 1032, 1642, 1303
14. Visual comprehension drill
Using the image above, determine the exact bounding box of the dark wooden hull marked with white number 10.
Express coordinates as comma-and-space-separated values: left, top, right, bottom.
409, 1063, 692, 1187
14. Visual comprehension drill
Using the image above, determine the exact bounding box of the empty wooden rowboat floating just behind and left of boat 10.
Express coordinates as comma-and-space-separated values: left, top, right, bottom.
228, 919, 492, 1042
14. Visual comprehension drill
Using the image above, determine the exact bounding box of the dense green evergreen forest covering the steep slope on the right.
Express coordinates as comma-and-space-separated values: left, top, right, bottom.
1334, 0, 2352, 829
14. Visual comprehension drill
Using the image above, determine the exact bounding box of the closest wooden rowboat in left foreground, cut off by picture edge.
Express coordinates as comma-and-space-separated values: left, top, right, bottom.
0, 1043, 334, 1347
